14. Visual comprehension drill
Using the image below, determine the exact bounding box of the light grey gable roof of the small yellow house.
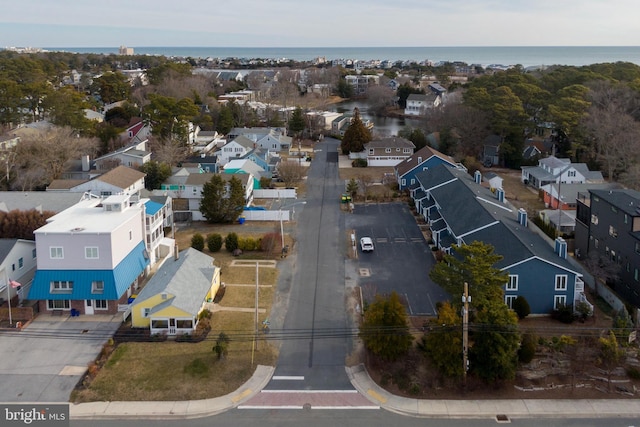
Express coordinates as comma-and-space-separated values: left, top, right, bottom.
134, 248, 217, 315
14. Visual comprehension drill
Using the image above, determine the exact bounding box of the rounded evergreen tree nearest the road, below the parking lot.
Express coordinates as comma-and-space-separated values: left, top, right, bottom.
360, 292, 413, 361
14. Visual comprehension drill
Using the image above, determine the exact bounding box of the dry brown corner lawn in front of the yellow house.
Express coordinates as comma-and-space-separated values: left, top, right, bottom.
72, 312, 277, 402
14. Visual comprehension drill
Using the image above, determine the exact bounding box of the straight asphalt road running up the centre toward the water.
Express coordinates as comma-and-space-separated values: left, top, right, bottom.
267, 138, 353, 390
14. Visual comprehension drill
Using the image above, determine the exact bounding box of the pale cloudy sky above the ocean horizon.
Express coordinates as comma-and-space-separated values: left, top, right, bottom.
0, 0, 640, 48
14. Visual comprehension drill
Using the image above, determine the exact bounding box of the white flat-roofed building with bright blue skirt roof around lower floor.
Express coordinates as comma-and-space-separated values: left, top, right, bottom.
28, 195, 149, 315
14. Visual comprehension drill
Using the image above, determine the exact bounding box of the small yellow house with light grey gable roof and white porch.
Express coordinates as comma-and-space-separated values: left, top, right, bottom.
131, 248, 220, 335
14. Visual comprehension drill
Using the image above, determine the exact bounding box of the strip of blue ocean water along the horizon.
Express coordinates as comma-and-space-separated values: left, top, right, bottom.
44, 46, 640, 67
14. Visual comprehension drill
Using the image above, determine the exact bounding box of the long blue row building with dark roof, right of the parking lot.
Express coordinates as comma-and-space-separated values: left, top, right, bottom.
412, 165, 592, 315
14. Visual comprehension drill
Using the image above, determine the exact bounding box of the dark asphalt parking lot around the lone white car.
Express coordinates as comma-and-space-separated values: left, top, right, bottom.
345, 203, 449, 316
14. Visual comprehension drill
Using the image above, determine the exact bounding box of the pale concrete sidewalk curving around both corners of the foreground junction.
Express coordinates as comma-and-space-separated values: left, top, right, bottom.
69, 365, 640, 422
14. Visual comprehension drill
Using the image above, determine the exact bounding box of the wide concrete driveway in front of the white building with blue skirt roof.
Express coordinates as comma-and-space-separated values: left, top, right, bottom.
0, 314, 122, 402
